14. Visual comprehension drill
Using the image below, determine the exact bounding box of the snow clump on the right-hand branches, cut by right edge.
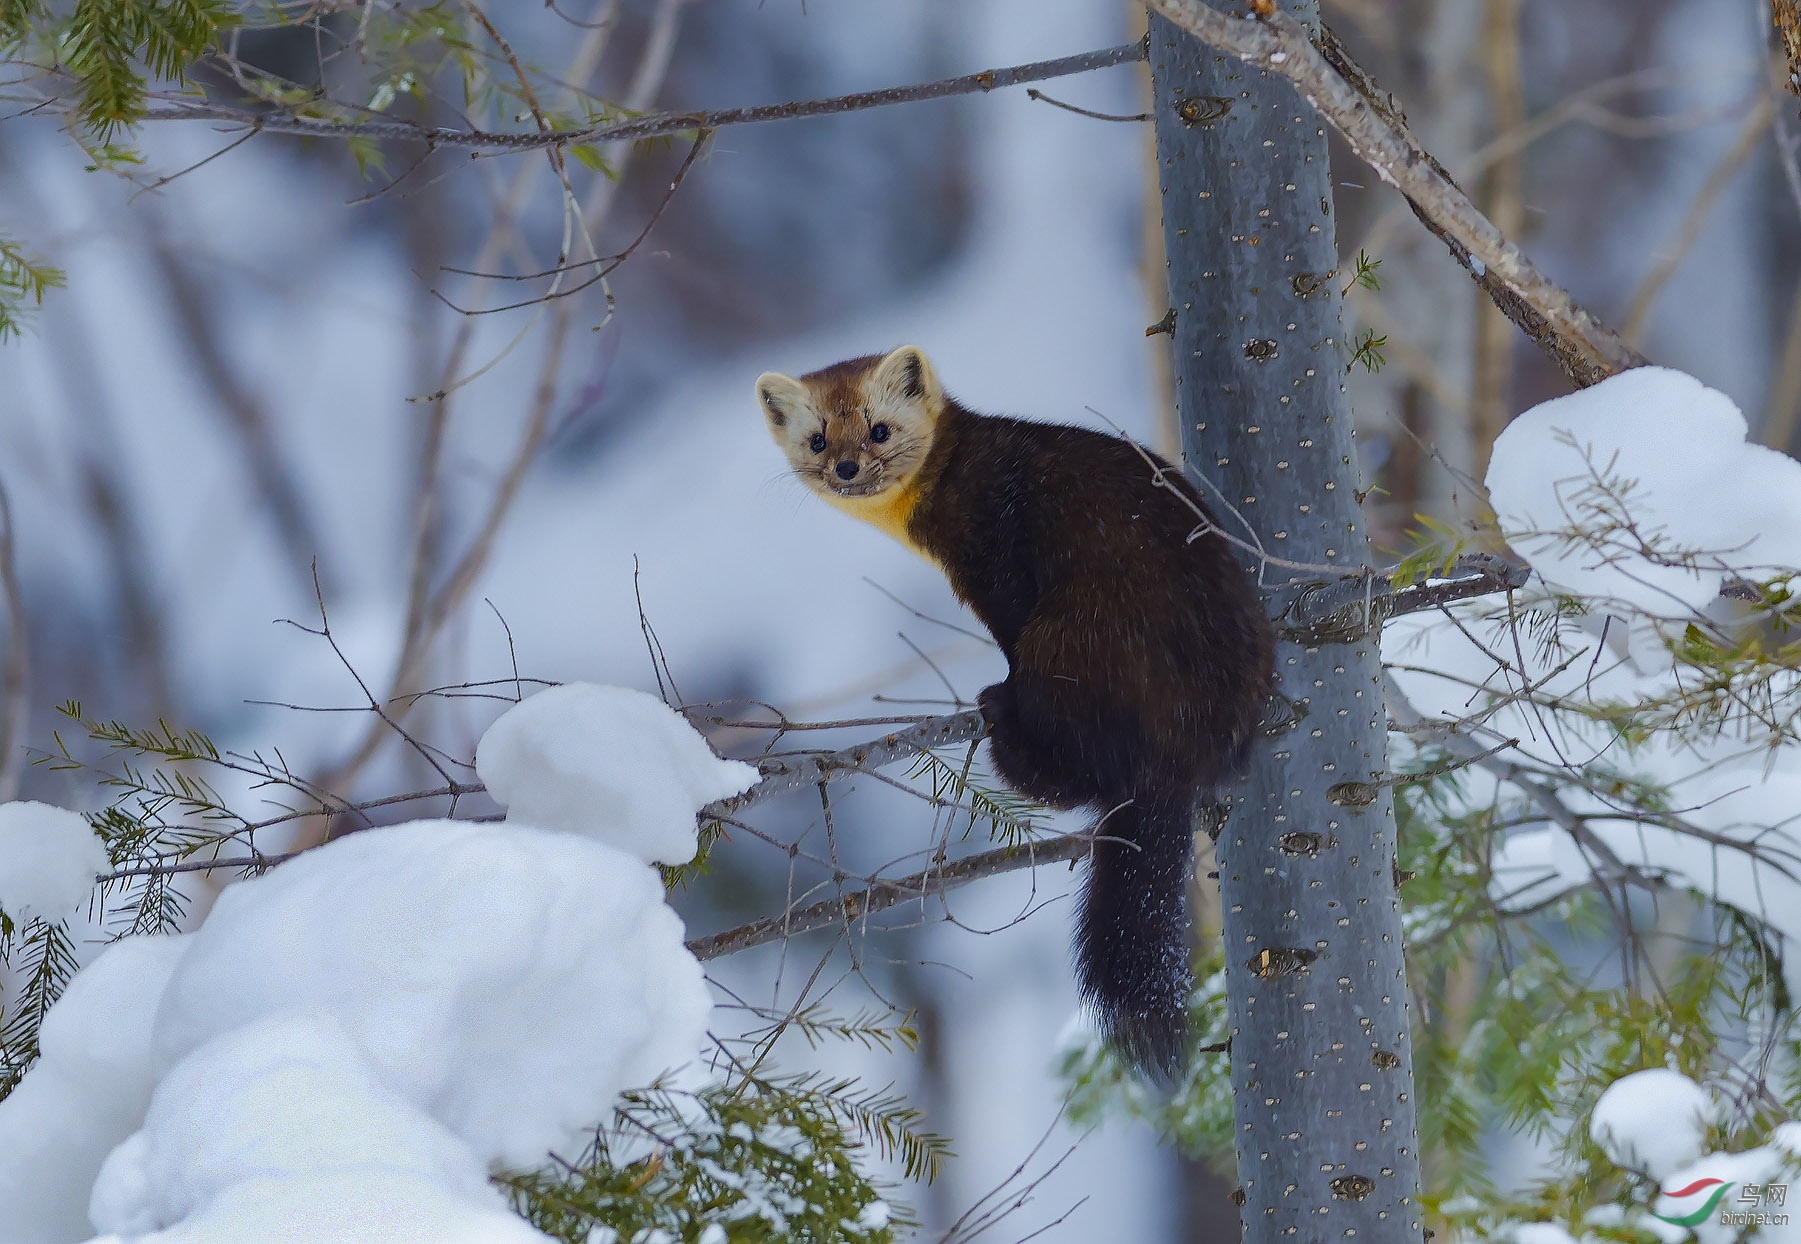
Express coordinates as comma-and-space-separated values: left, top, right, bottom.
1488, 367, 1801, 616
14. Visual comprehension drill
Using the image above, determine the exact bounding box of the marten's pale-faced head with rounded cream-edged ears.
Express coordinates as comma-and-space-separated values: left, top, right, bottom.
756, 346, 944, 508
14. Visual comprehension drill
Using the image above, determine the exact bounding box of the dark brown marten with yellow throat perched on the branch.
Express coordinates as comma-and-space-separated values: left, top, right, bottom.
756, 346, 1272, 1075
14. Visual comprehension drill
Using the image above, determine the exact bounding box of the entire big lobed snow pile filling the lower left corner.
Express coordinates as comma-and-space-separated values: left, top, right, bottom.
0, 821, 711, 1244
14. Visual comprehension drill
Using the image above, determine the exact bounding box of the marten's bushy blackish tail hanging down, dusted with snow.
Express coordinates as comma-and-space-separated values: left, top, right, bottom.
1075, 796, 1194, 1080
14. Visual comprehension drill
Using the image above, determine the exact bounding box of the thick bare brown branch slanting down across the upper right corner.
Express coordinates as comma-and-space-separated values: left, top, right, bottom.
1145, 0, 1646, 385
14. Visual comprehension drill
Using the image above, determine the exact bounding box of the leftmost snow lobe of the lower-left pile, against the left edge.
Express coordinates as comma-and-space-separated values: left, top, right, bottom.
0, 936, 187, 1244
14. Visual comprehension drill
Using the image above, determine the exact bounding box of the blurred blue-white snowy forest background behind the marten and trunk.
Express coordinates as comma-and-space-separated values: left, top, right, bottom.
0, 0, 1801, 1240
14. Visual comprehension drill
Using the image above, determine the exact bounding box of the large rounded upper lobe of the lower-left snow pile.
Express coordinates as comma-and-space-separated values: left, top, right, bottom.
155, 821, 711, 1167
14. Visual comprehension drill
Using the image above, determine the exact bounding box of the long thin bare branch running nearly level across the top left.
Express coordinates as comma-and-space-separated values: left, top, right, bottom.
123, 40, 1145, 151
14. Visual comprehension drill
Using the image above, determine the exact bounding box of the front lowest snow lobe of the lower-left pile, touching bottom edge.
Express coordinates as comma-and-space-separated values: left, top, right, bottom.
90, 1012, 546, 1244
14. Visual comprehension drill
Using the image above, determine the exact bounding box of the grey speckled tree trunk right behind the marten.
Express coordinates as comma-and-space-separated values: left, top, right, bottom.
1151, 9, 1423, 1244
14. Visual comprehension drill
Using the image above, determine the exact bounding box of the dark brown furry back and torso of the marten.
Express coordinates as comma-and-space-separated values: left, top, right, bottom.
908, 403, 1270, 807
